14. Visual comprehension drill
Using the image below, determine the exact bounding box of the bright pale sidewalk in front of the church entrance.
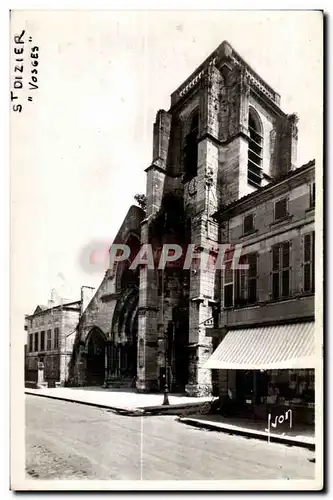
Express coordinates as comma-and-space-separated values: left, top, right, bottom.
24, 387, 211, 415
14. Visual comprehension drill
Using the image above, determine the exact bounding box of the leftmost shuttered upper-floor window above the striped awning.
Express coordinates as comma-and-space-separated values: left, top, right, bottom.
235, 252, 257, 306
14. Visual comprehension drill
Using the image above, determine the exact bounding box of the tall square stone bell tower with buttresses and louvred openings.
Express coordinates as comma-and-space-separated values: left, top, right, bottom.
137, 42, 297, 395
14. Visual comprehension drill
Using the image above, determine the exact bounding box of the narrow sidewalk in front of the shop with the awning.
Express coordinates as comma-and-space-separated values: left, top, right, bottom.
179, 415, 315, 450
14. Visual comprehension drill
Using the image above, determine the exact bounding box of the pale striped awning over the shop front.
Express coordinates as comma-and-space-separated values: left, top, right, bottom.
204, 321, 316, 370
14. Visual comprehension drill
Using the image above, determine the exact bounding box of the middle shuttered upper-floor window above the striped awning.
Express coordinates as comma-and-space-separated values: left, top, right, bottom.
272, 241, 290, 300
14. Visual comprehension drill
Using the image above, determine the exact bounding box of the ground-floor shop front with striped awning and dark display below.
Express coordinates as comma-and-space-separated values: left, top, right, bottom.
206, 322, 315, 425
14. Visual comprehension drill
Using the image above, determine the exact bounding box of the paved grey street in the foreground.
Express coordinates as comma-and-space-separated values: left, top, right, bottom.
26, 395, 315, 480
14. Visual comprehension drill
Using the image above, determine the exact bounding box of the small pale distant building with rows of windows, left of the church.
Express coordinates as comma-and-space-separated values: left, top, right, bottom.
25, 301, 81, 387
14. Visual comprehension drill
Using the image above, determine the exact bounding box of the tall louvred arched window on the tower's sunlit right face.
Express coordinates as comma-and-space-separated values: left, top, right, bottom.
247, 109, 263, 187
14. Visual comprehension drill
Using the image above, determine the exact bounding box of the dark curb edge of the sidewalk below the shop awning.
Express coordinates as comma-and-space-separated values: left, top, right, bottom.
178, 417, 316, 451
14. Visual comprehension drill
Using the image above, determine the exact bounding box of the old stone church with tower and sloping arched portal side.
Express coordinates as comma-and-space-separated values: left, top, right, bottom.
71, 42, 314, 396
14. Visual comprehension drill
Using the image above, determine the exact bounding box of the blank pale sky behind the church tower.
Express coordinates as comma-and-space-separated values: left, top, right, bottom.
10, 11, 323, 315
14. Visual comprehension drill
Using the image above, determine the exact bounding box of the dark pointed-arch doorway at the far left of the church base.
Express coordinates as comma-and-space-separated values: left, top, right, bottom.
87, 328, 105, 385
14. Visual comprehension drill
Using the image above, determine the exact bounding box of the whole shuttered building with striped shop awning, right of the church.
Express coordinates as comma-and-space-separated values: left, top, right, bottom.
206, 161, 314, 422
